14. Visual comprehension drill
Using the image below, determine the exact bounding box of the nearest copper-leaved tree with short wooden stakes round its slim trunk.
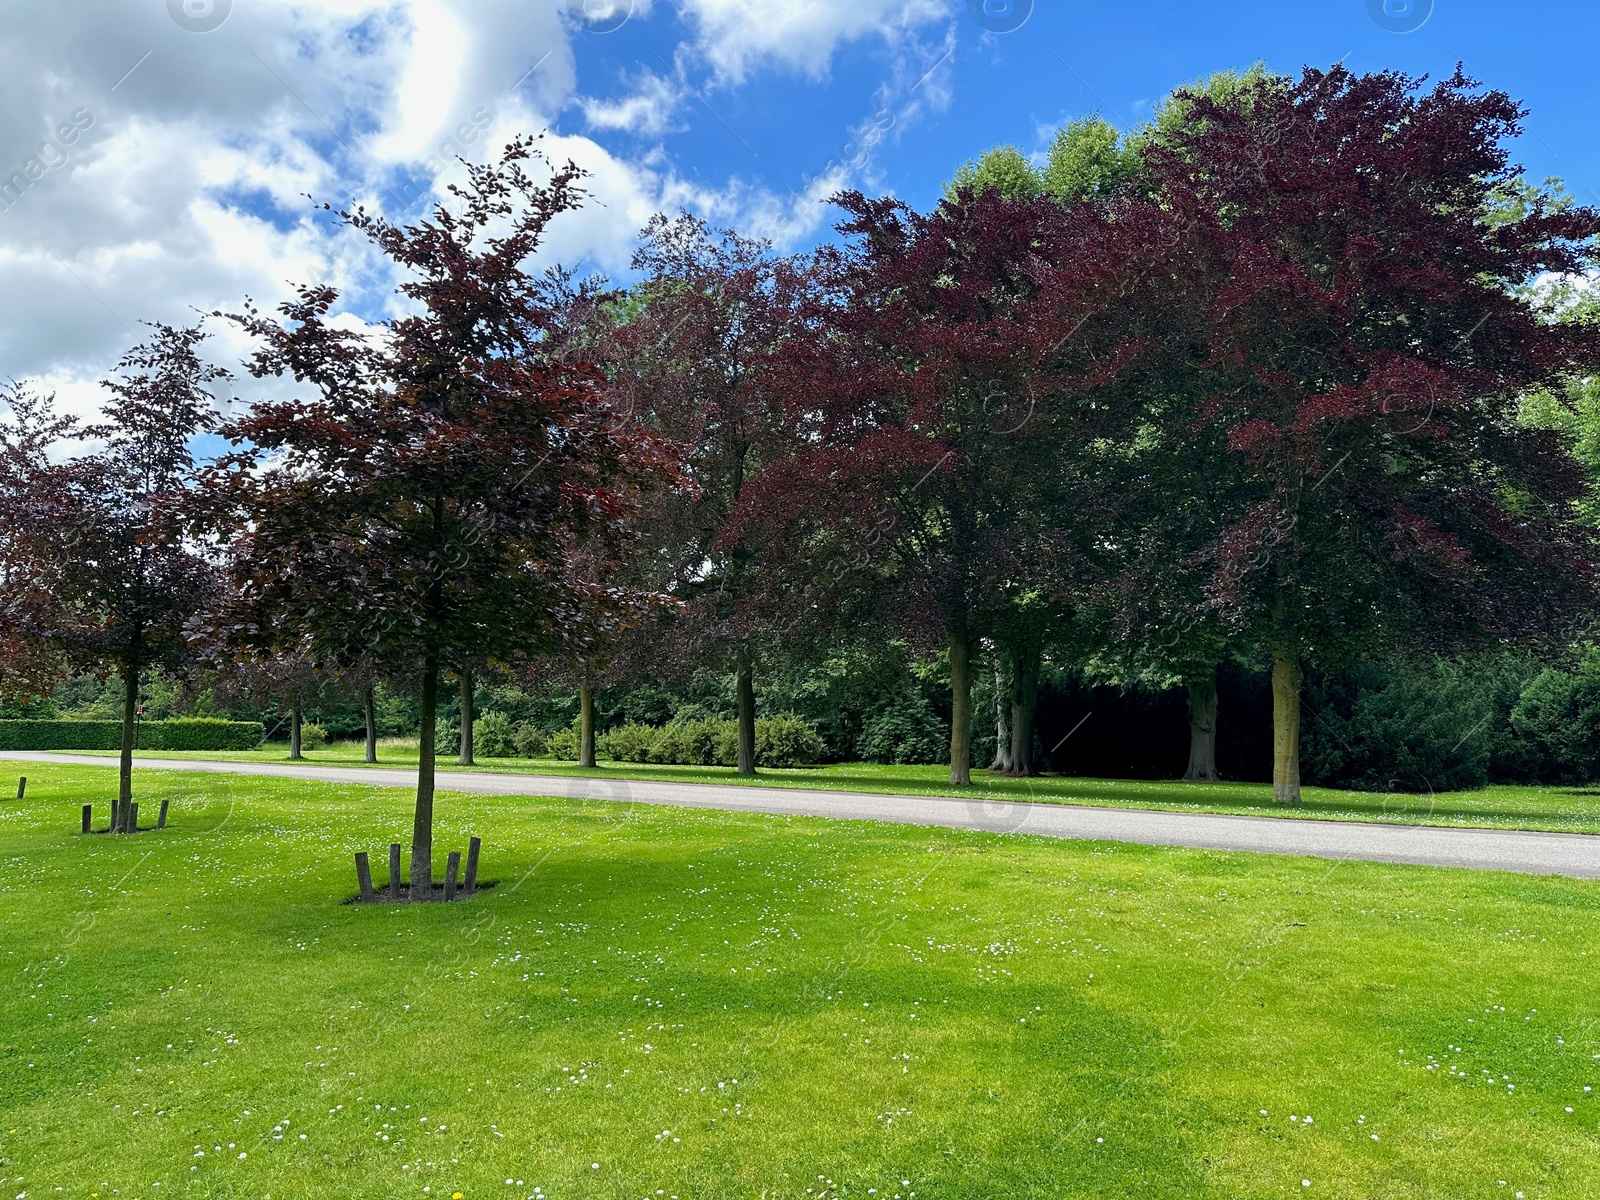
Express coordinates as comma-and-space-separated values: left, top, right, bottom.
201, 139, 677, 899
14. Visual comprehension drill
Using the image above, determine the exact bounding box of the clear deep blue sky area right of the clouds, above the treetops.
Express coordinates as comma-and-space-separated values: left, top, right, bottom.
576, 0, 1600, 251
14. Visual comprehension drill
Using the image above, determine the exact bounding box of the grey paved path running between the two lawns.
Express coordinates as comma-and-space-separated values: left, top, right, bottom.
9, 750, 1600, 878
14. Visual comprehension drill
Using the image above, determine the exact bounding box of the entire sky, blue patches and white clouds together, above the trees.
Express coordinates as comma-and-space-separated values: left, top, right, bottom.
0, 0, 1600, 413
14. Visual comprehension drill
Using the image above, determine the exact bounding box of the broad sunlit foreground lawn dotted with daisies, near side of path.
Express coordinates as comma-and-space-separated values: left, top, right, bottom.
0, 766, 1600, 1200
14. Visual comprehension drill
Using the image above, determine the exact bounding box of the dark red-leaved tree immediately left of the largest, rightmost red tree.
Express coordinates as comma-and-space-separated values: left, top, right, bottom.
752, 189, 1138, 786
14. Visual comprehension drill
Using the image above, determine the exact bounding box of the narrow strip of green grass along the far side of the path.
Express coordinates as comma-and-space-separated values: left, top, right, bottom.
59, 739, 1600, 834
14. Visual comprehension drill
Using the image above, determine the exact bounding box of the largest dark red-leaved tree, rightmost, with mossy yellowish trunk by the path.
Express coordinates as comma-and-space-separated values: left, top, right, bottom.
1142, 67, 1600, 803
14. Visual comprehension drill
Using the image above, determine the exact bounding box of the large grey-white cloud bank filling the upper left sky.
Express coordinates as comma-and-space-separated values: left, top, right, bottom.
0, 0, 611, 411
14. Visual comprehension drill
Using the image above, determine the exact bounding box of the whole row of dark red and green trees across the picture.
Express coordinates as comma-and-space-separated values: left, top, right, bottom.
0, 67, 1600, 888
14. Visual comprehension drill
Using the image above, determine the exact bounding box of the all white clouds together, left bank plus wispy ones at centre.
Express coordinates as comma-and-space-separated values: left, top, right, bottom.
0, 0, 972, 422
